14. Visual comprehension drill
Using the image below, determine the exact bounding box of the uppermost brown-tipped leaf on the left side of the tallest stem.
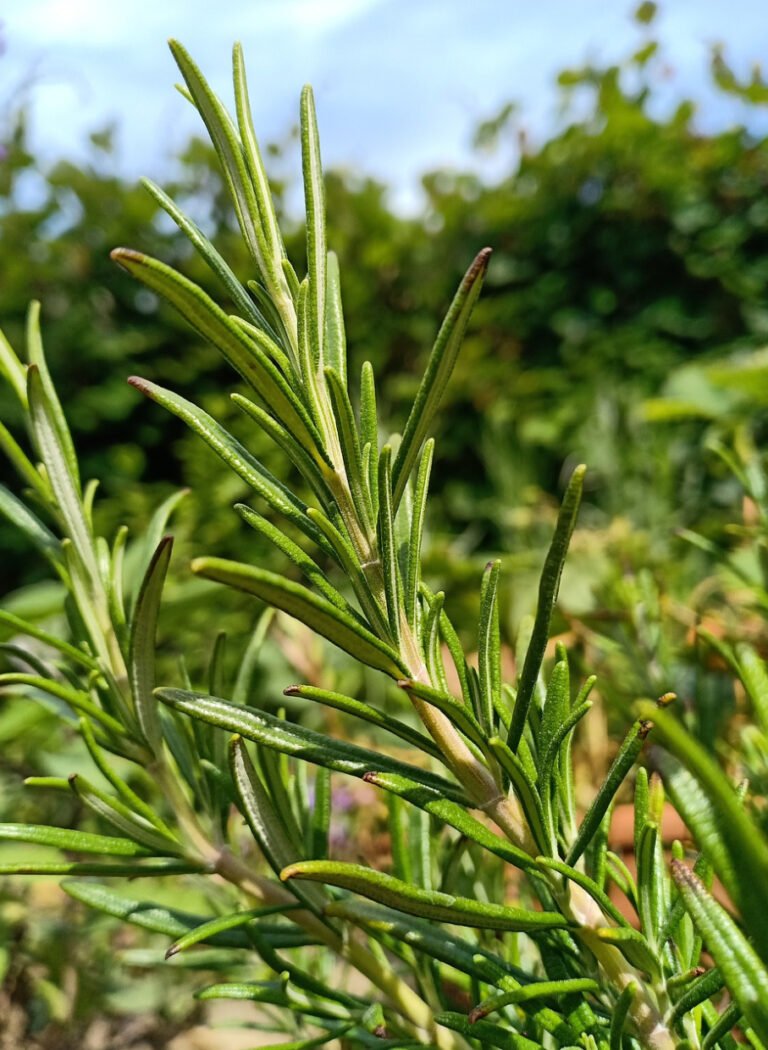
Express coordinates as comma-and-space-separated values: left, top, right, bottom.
111, 248, 327, 462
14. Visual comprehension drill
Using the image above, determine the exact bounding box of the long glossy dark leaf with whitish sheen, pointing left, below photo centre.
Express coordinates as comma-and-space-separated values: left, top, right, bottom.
155, 689, 468, 805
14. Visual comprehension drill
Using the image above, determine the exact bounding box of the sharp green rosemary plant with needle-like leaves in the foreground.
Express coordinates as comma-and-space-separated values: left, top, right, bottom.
0, 42, 768, 1050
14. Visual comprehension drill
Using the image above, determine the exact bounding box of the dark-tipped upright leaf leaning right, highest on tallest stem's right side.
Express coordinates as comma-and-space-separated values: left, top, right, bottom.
392, 248, 491, 511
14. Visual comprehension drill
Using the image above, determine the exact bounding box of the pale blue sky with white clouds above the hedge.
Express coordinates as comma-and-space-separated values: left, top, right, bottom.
0, 0, 768, 208
